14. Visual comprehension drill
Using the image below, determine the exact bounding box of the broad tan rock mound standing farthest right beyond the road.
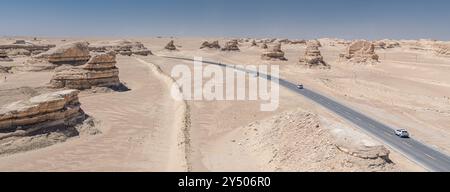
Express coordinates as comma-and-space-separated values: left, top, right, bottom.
340, 41, 379, 64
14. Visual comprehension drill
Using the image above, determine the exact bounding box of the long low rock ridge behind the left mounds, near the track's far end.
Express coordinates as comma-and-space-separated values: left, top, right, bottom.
89, 40, 153, 56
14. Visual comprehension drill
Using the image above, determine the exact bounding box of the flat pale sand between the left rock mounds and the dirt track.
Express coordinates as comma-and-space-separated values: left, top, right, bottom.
0, 57, 185, 171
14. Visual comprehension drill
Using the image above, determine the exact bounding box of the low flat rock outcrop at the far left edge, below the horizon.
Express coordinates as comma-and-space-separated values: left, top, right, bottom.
0, 40, 55, 56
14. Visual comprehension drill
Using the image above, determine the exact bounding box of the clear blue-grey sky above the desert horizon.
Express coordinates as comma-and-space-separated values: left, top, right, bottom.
0, 0, 450, 40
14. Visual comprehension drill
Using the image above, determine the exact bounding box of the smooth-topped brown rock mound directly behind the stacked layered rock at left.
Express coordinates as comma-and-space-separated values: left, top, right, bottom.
36, 42, 91, 65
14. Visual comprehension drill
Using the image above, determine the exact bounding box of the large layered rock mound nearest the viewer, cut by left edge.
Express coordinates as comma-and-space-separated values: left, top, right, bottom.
0, 90, 100, 155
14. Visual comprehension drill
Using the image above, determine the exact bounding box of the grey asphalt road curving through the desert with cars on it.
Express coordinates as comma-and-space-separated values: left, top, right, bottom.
166, 57, 450, 172
